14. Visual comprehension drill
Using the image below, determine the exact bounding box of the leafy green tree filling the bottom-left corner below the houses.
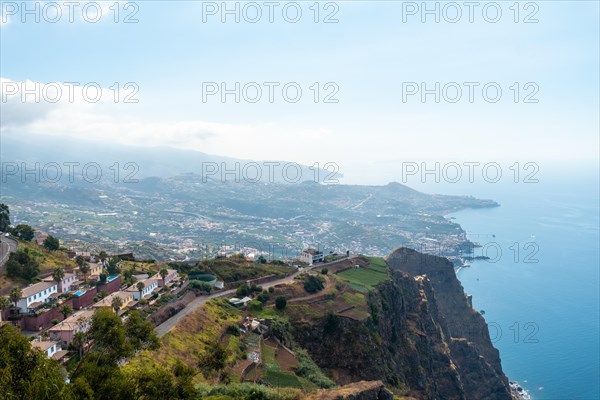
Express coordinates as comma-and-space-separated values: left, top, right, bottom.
0, 324, 74, 400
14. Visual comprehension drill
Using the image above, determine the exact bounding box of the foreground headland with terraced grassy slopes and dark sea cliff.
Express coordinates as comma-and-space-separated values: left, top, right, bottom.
132, 249, 511, 400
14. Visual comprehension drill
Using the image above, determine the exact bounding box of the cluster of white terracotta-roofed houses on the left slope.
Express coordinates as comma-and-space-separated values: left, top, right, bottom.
4, 256, 179, 360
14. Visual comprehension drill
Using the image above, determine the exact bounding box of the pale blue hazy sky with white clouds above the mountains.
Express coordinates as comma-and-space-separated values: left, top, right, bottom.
0, 1, 600, 184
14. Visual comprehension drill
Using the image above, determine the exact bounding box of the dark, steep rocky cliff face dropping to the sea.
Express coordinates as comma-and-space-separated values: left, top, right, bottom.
294, 249, 511, 400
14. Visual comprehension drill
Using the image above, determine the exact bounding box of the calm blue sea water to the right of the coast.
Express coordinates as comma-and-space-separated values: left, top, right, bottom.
452, 176, 600, 400
